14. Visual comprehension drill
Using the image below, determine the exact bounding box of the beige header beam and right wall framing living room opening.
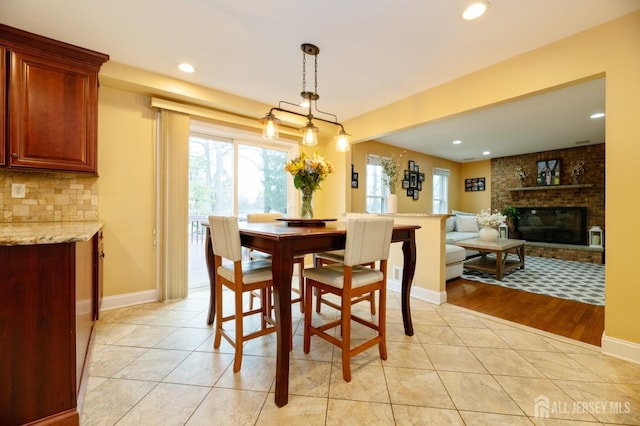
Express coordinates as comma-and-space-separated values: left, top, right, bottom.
345, 12, 640, 344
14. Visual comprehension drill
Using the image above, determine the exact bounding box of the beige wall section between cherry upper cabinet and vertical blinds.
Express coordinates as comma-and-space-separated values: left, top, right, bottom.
98, 86, 156, 296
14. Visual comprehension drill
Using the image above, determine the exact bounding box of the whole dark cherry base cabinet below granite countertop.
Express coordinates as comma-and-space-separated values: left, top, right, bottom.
0, 231, 102, 425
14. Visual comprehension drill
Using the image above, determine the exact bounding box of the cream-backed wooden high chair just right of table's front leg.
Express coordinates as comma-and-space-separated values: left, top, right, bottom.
303, 217, 393, 382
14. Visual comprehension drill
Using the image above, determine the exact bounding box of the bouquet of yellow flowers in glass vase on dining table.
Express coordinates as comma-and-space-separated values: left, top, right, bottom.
284, 151, 333, 218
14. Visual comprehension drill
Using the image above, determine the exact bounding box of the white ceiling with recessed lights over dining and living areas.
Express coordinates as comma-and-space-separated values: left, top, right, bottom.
0, 0, 640, 162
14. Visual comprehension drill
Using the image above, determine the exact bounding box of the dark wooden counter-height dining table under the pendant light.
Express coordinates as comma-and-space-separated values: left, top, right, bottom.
202, 221, 420, 407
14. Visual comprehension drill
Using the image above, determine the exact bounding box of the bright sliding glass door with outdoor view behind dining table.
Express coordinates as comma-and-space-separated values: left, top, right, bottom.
187, 122, 294, 289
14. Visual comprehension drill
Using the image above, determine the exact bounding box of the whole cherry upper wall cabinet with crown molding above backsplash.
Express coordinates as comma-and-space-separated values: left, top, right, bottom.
0, 24, 109, 173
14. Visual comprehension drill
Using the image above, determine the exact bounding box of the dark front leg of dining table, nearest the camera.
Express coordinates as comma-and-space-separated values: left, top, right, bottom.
271, 243, 293, 407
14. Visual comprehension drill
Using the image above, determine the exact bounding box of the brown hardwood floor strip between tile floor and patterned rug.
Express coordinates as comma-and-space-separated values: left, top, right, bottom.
447, 278, 604, 346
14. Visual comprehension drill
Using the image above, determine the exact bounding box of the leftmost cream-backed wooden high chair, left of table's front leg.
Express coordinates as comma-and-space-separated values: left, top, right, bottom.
209, 216, 276, 373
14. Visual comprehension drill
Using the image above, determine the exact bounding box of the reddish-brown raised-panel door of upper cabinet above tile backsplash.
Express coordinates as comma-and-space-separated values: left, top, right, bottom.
8, 51, 98, 173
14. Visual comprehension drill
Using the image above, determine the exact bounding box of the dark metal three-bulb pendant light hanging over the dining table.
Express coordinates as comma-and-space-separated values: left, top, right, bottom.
260, 43, 349, 152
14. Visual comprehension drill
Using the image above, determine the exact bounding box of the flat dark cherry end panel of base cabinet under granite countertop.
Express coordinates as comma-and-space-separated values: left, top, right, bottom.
0, 243, 77, 425
